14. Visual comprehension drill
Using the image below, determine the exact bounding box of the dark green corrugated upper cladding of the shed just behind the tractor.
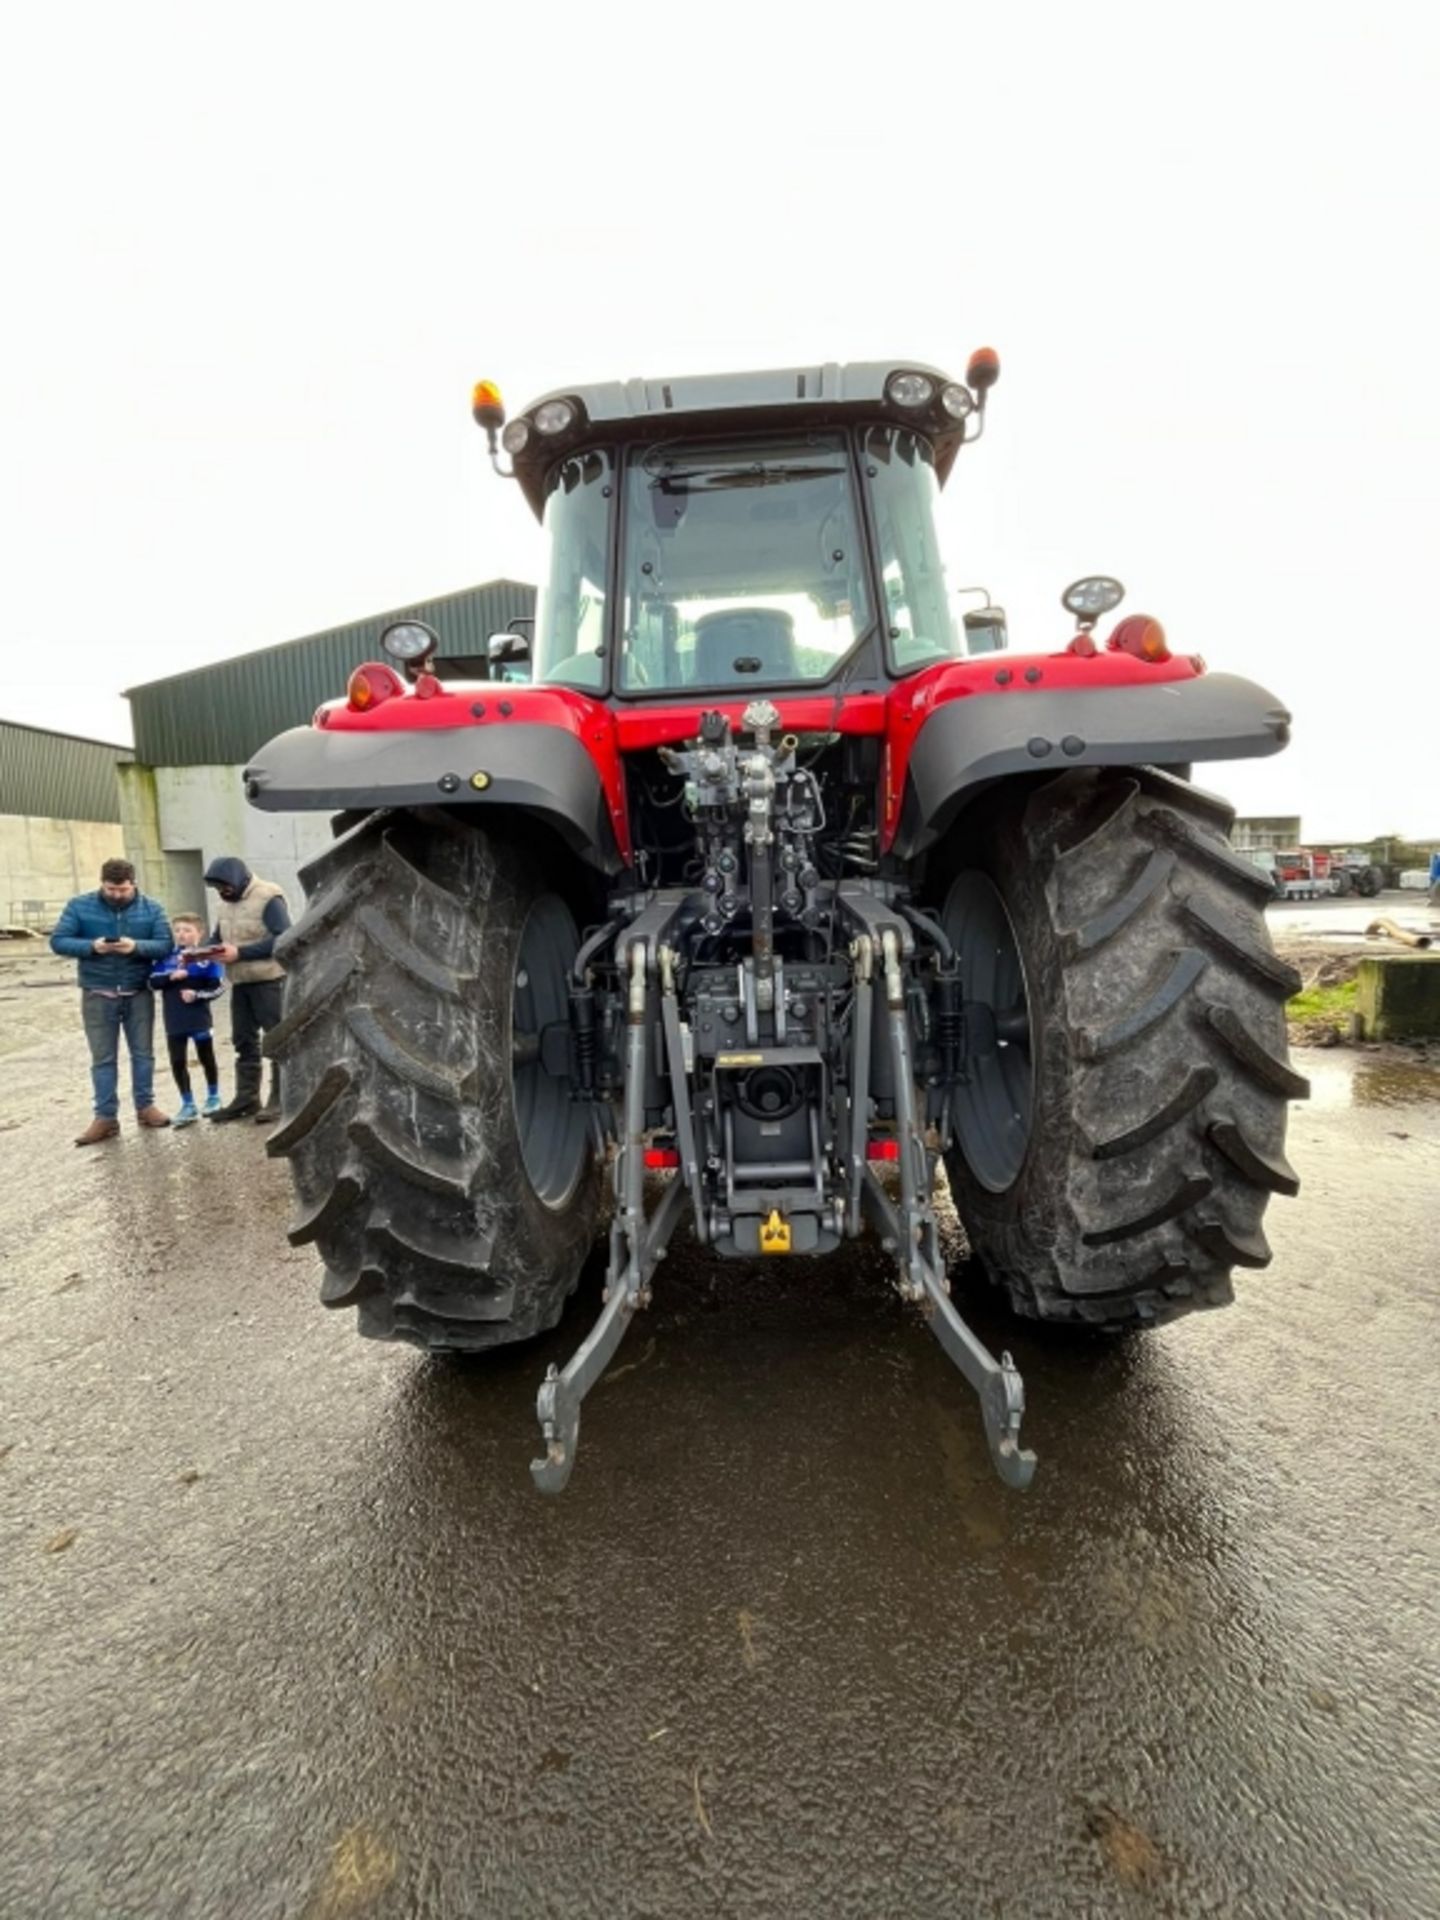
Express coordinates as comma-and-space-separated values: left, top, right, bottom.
127, 580, 536, 766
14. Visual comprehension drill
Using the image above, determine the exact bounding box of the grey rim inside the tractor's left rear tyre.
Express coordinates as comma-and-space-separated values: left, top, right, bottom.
511, 893, 589, 1212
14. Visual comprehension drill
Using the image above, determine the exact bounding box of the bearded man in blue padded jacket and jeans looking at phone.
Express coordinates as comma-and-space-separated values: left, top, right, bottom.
50, 860, 173, 1146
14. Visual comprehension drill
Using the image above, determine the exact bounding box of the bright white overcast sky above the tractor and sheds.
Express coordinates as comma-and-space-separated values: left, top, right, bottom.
0, 0, 1440, 835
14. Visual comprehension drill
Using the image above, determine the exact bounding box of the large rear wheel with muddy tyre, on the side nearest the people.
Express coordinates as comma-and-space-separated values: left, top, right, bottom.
265, 812, 599, 1350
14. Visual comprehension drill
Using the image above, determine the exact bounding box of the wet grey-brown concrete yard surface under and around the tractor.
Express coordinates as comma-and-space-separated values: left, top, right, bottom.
0, 952, 1440, 1920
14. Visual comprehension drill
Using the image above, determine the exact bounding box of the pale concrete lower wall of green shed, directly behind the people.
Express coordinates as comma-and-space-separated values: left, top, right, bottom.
119, 766, 332, 918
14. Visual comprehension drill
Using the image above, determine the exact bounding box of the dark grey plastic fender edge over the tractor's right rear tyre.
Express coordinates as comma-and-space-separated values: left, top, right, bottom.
891, 674, 1290, 858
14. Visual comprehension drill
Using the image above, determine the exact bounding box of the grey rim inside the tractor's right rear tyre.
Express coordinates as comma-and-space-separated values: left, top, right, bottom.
943, 870, 1035, 1194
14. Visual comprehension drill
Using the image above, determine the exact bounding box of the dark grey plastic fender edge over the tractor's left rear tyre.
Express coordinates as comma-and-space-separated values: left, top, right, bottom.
244, 722, 622, 874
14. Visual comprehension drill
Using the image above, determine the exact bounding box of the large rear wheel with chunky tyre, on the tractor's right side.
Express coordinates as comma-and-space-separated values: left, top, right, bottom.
937, 768, 1309, 1329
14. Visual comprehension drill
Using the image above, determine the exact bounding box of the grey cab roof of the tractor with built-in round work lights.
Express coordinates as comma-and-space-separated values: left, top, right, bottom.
515, 359, 966, 515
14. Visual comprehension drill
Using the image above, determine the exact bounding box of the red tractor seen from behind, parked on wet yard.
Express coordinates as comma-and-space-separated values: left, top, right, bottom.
246, 362, 1306, 1490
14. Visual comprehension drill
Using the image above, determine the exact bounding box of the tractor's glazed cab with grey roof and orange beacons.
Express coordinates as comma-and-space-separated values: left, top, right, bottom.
476, 353, 998, 701
